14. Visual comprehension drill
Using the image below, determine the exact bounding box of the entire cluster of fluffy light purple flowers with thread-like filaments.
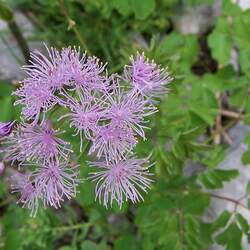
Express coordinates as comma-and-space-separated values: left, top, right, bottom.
0, 47, 171, 214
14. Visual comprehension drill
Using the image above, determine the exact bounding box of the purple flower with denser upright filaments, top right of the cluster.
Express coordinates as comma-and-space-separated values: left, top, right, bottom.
124, 53, 172, 97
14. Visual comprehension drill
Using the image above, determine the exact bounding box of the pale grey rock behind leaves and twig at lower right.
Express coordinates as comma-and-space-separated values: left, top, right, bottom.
204, 124, 250, 250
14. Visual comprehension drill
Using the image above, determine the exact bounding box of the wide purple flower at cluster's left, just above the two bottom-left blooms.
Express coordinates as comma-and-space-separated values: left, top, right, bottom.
5, 121, 71, 164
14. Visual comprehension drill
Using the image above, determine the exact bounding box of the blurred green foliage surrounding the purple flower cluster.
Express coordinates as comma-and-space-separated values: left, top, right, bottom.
0, 0, 250, 250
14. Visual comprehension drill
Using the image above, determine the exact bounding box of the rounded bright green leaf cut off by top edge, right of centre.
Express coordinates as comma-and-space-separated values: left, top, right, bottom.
132, 0, 155, 20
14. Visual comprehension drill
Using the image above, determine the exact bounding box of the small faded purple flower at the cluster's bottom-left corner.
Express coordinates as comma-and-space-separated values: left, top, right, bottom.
10, 173, 40, 216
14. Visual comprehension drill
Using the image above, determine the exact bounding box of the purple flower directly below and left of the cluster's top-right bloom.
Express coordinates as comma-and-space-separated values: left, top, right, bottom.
106, 80, 157, 139
